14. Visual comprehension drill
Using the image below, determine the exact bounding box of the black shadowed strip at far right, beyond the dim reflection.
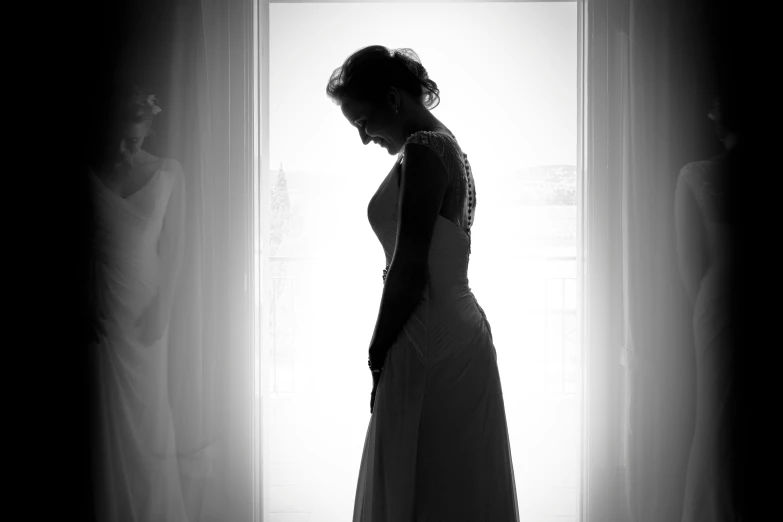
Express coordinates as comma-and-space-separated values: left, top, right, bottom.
691, 0, 781, 520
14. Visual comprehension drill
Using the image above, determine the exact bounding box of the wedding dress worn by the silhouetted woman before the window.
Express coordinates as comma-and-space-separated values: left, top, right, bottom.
353, 131, 519, 522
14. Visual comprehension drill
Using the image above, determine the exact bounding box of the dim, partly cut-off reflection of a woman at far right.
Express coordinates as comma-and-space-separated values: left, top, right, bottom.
675, 93, 737, 522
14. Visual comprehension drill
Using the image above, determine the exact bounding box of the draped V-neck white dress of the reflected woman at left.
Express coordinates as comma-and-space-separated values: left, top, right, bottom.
91, 161, 187, 522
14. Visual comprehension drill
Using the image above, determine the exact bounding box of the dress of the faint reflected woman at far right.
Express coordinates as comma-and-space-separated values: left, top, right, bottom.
680, 155, 737, 522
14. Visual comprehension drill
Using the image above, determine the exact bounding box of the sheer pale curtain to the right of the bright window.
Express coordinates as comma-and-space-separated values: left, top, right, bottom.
584, 0, 752, 522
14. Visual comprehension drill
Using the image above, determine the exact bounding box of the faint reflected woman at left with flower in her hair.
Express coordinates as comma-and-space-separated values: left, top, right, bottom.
90, 83, 186, 522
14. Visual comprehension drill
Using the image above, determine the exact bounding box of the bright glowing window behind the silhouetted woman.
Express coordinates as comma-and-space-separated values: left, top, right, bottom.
261, 2, 582, 522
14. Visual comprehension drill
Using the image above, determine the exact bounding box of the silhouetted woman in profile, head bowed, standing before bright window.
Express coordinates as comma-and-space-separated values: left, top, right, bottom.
327, 46, 519, 522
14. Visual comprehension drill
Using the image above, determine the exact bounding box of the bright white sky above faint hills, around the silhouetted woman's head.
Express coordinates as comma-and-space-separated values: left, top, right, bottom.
269, 2, 577, 176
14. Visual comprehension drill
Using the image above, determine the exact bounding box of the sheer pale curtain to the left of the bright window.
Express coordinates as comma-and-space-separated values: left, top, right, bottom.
84, 0, 254, 521
